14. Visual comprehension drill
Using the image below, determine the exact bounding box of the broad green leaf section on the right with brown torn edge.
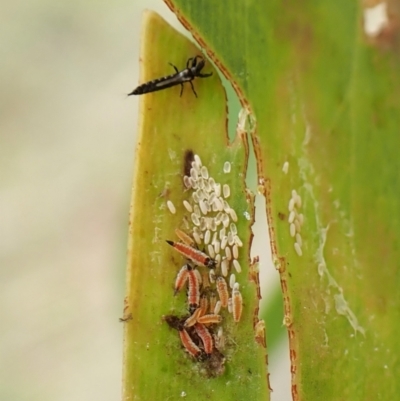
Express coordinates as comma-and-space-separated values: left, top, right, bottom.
162, 0, 400, 400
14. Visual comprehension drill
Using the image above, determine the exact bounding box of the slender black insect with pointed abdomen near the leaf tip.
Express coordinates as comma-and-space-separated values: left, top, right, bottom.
128, 56, 212, 97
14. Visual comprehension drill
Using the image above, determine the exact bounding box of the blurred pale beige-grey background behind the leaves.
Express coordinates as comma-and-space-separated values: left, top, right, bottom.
0, 0, 290, 401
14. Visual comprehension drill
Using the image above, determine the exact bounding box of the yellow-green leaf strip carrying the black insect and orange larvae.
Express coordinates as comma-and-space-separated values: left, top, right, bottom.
123, 12, 268, 401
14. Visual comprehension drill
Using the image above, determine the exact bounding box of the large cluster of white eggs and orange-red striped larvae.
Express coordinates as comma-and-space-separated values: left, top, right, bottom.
164, 151, 243, 374
